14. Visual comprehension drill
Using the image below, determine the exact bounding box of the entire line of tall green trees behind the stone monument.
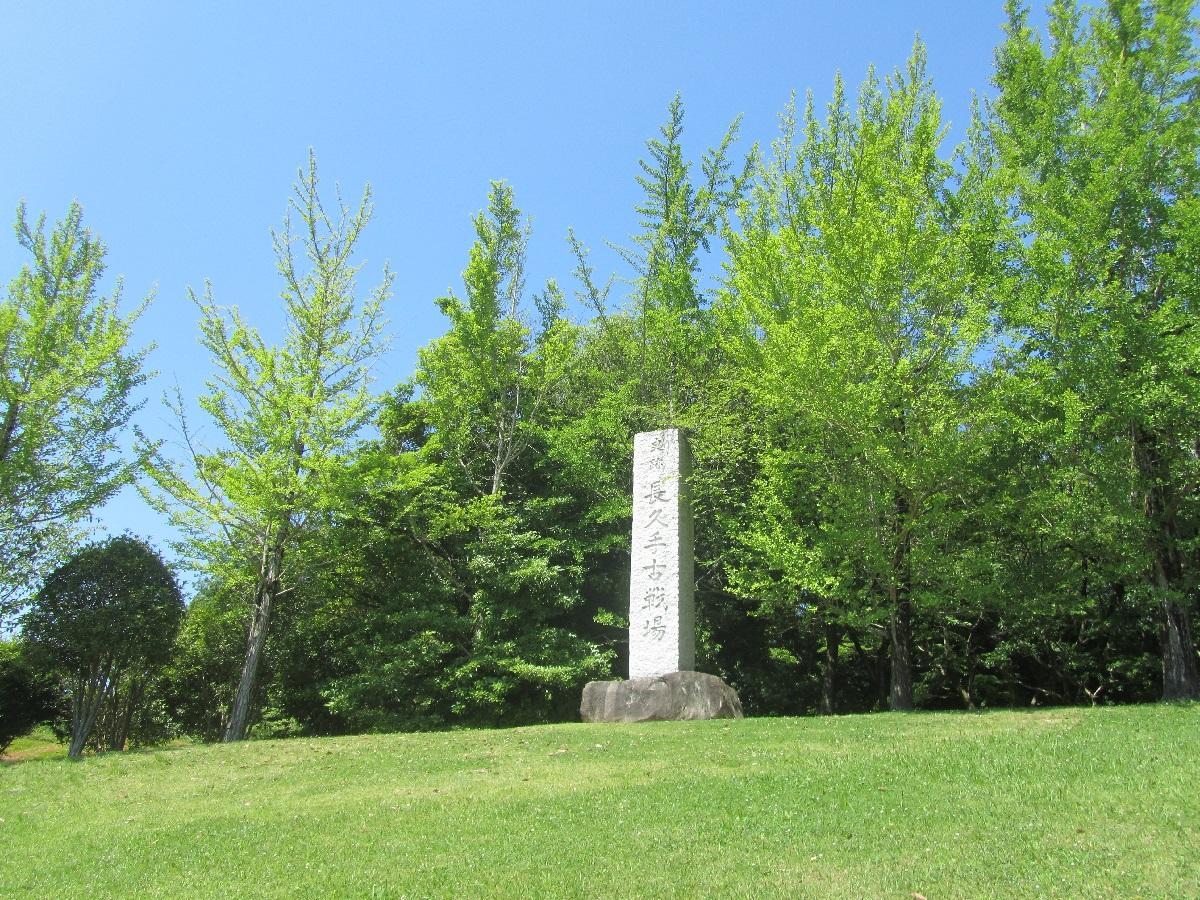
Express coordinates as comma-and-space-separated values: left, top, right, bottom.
0, 0, 1200, 753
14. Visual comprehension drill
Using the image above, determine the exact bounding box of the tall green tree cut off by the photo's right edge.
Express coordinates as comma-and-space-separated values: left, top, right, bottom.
990, 0, 1200, 700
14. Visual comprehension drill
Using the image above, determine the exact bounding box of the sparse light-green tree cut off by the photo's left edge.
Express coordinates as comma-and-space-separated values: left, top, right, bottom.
0, 204, 149, 624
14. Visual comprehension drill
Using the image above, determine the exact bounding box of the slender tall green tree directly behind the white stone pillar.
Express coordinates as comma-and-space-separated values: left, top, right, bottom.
559, 96, 755, 681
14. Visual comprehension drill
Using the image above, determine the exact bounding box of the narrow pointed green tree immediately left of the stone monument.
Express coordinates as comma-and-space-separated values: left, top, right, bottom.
412, 182, 608, 722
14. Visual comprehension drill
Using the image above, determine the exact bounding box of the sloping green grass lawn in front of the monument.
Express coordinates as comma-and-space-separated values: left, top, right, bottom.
0, 704, 1200, 900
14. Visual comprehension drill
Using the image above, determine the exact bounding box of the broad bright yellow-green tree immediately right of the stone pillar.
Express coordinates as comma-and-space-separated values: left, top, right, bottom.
731, 42, 995, 709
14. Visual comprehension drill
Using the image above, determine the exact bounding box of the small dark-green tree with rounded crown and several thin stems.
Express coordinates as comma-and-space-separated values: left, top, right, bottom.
22, 536, 184, 757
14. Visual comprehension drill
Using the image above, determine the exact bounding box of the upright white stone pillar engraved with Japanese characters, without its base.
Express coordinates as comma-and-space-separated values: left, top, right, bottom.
629, 428, 696, 678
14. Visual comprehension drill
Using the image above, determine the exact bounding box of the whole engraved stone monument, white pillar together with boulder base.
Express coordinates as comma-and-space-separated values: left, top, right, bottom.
580, 428, 742, 722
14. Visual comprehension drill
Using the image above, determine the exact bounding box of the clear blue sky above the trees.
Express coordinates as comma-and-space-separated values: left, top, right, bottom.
0, 0, 1032, 580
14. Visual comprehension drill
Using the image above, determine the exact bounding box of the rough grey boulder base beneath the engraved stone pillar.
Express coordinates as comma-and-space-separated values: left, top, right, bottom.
580, 672, 742, 722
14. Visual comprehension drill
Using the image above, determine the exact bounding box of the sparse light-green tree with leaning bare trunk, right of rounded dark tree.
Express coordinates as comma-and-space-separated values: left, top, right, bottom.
144, 154, 392, 740
